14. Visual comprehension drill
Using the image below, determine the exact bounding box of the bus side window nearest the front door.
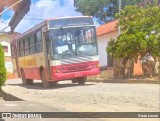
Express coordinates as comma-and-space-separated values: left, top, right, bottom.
36, 31, 42, 52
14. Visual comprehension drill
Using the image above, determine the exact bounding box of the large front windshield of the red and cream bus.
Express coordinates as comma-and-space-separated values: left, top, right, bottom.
50, 26, 98, 59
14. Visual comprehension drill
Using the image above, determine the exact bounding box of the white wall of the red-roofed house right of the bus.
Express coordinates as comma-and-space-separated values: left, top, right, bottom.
97, 31, 118, 67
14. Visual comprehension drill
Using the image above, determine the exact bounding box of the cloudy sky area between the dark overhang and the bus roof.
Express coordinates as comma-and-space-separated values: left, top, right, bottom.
15, 0, 81, 33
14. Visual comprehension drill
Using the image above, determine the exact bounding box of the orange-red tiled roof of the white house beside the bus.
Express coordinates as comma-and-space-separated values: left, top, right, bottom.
97, 20, 118, 36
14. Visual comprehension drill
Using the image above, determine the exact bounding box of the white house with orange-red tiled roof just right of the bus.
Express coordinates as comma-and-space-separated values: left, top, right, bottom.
97, 20, 119, 68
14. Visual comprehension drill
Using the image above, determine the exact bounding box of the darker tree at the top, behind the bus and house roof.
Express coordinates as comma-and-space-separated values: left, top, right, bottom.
74, 0, 157, 24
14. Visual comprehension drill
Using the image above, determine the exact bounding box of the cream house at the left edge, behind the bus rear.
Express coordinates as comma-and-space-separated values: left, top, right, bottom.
0, 33, 18, 78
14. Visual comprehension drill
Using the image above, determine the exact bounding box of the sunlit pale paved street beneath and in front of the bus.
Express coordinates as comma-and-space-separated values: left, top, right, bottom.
0, 79, 160, 121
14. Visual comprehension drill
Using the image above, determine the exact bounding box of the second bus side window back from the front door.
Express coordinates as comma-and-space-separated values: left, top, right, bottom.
29, 34, 36, 54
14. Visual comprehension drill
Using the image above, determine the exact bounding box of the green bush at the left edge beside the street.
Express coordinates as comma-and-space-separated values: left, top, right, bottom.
0, 45, 6, 90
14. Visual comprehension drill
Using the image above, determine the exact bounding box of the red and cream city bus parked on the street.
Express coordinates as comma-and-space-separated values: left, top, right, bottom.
11, 16, 99, 87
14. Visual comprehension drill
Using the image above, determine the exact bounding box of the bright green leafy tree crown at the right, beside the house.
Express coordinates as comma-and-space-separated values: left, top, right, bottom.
107, 6, 160, 58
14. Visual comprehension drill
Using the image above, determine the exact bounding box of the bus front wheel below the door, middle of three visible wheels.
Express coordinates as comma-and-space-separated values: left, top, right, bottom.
41, 70, 52, 88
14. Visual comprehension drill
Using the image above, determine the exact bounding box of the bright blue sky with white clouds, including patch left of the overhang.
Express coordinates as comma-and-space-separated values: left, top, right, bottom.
0, 0, 82, 33
